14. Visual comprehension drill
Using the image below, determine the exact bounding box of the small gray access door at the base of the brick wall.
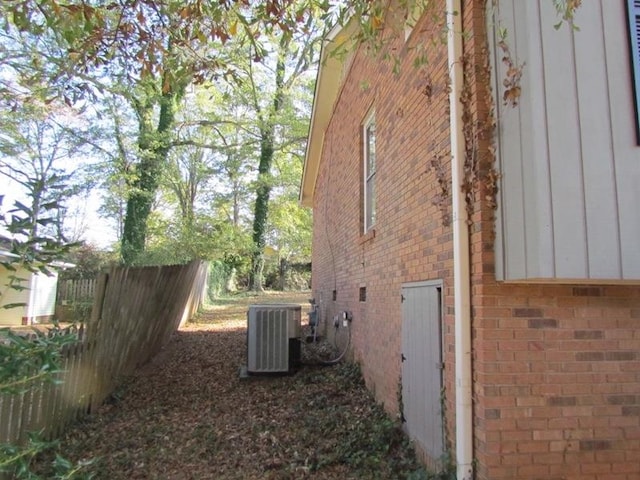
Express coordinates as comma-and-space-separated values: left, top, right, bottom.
402, 281, 444, 460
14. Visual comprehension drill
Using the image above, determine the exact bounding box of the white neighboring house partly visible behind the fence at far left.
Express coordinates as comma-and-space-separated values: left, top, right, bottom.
0, 250, 74, 326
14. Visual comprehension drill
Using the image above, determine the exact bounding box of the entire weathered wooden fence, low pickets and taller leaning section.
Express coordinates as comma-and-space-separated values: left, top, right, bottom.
0, 261, 207, 450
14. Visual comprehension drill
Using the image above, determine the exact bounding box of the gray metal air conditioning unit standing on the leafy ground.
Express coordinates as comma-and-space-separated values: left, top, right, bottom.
247, 304, 302, 374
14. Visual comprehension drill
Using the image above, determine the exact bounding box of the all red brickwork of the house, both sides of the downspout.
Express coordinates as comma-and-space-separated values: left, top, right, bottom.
313, 0, 640, 480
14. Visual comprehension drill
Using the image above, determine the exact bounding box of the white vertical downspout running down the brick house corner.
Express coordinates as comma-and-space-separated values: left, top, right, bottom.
447, 0, 473, 480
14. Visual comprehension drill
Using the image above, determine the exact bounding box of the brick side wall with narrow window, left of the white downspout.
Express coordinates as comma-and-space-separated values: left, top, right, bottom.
312, 0, 453, 434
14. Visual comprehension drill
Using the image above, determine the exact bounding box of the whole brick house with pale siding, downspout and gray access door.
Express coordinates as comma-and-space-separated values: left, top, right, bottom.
300, 0, 640, 480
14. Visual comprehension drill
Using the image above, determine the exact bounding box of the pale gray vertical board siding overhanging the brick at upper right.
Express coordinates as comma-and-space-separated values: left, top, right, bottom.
487, 0, 640, 282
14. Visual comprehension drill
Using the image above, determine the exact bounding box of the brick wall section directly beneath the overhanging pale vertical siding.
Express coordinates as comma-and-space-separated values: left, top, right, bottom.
473, 282, 640, 480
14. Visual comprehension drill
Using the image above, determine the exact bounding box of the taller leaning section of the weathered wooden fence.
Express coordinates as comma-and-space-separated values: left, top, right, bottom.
87, 262, 207, 405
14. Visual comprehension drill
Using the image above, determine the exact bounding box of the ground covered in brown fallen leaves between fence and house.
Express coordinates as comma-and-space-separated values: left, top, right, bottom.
33, 294, 425, 480
